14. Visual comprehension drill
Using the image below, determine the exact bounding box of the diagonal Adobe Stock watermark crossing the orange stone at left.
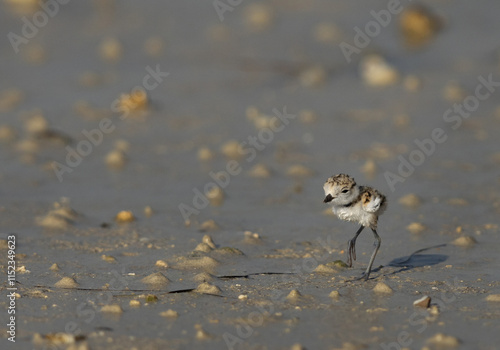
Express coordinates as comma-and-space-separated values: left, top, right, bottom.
52, 64, 170, 182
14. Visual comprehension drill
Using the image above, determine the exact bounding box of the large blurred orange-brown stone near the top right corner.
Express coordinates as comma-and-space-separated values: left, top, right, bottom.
399, 4, 442, 48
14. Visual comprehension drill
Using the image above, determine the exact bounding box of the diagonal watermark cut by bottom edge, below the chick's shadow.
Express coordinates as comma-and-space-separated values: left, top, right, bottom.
379, 277, 460, 350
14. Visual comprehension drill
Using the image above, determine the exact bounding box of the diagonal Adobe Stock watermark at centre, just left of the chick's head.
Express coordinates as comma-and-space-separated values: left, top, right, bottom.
178, 106, 296, 222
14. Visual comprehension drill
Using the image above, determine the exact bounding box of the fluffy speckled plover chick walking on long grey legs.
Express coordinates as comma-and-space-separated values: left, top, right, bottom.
323, 174, 387, 280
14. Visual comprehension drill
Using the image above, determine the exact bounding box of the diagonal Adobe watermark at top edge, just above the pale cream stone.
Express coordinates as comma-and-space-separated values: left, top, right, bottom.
339, 0, 411, 63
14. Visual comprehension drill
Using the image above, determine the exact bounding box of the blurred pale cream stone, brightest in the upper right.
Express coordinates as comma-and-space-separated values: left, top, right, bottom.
360, 54, 399, 86
